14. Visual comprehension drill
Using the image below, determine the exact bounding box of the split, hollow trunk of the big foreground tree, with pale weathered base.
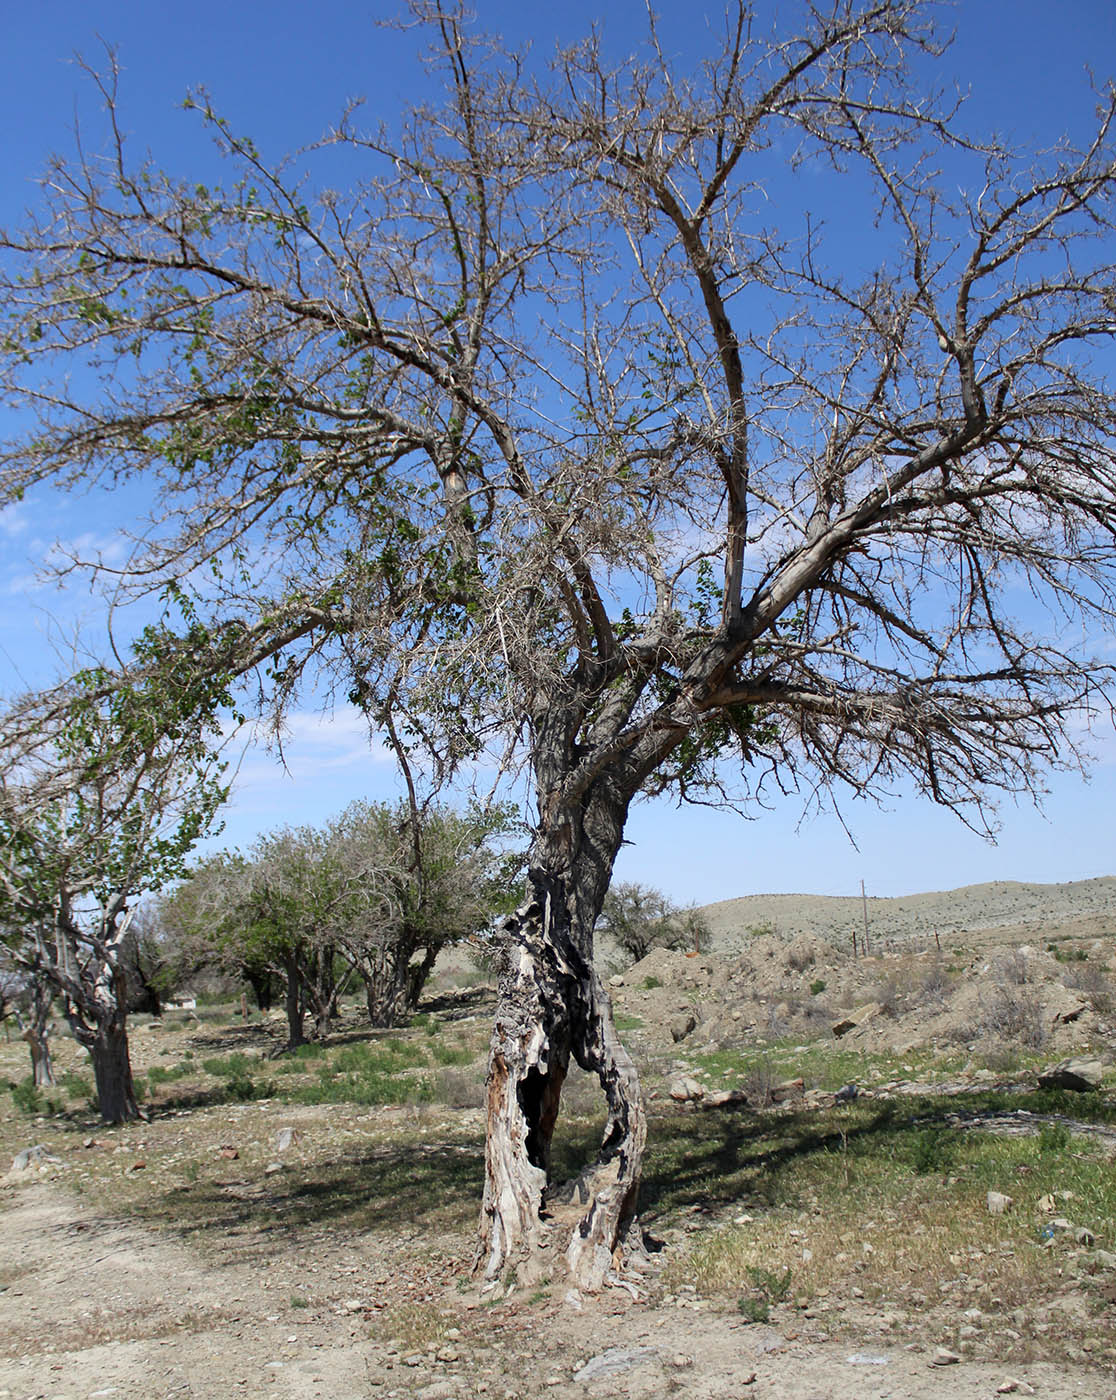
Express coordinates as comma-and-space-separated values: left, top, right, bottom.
477, 792, 646, 1291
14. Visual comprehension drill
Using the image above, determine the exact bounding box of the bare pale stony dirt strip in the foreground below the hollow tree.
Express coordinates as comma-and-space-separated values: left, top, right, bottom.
0, 1180, 1116, 1400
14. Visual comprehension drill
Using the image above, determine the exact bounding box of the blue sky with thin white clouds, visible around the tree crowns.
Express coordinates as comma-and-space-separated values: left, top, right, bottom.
0, 0, 1116, 902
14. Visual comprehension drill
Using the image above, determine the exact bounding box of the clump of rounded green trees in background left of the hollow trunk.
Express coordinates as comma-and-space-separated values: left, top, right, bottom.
162, 802, 521, 1046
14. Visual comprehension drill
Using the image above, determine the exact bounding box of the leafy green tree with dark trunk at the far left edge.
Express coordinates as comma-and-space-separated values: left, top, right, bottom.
0, 641, 227, 1123
